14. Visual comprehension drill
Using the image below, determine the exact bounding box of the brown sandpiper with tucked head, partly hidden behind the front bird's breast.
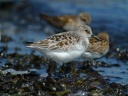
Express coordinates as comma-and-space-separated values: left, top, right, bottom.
83, 32, 109, 61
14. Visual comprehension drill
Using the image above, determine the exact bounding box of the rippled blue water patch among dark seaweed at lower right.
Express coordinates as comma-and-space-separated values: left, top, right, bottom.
96, 58, 128, 85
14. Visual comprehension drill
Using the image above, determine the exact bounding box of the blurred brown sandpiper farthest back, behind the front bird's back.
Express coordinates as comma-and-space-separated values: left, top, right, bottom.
40, 12, 91, 31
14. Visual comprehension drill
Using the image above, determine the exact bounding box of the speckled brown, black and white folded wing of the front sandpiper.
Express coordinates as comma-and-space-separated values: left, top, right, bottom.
29, 32, 79, 51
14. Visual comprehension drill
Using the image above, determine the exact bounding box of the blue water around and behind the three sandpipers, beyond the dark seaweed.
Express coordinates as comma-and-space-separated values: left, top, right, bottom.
0, 0, 128, 85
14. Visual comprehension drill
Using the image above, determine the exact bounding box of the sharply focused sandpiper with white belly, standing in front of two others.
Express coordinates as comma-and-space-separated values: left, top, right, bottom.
27, 25, 93, 76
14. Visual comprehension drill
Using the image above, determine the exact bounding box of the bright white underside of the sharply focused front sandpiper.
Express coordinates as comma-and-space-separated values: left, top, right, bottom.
38, 44, 85, 64
